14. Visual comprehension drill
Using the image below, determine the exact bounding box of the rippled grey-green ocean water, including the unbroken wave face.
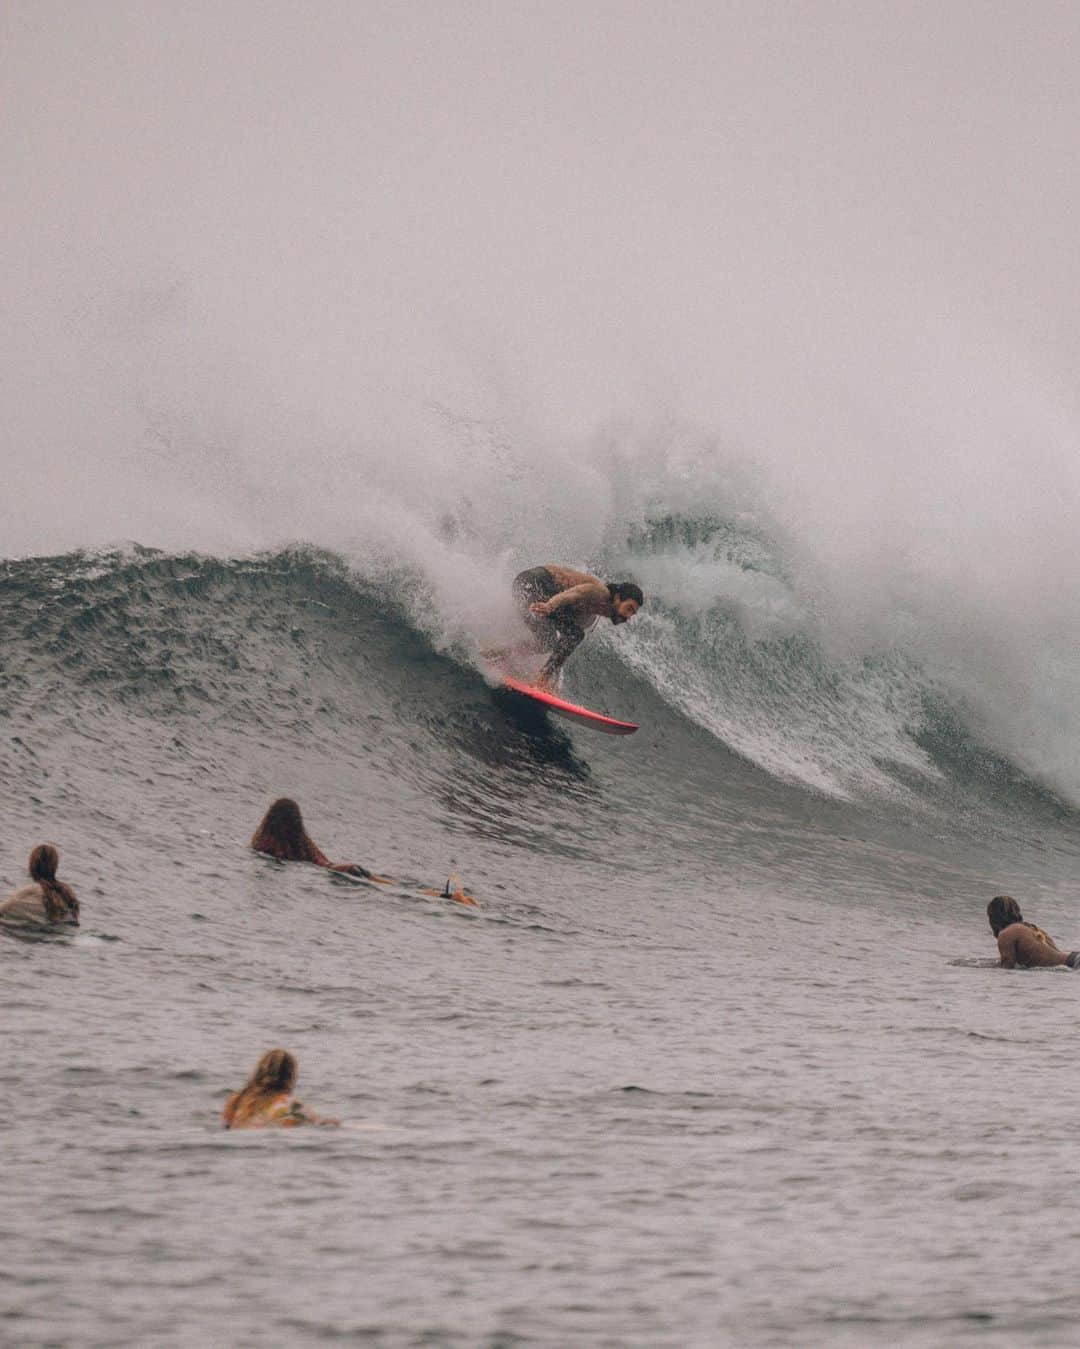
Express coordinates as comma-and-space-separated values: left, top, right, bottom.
0, 542, 1080, 1349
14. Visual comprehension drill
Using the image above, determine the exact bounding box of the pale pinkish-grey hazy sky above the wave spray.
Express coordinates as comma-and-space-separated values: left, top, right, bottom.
0, 0, 1080, 580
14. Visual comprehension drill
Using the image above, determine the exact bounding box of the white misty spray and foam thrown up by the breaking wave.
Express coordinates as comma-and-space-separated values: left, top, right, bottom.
8, 375, 1080, 803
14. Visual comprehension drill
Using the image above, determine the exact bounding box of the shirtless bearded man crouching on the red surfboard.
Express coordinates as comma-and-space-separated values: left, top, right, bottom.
512, 563, 644, 691
